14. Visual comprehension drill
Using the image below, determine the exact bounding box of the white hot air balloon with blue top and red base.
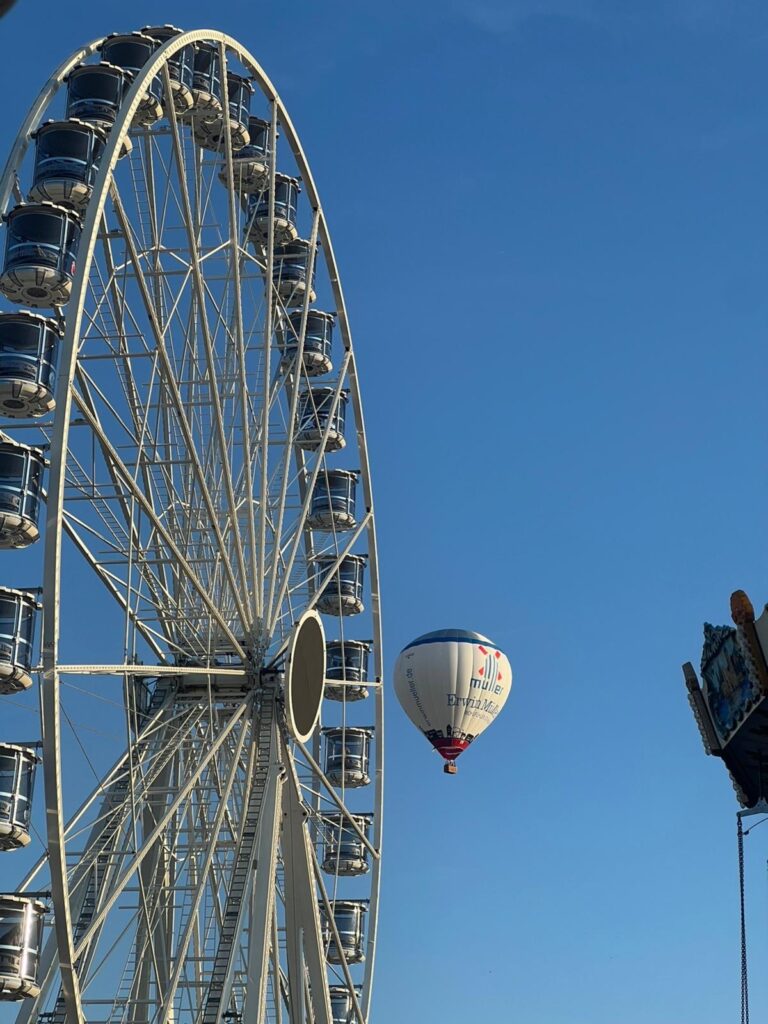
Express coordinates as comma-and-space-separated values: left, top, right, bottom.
394, 630, 512, 775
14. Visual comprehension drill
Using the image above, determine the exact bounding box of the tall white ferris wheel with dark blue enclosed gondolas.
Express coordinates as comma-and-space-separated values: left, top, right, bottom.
0, 26, 383, 1024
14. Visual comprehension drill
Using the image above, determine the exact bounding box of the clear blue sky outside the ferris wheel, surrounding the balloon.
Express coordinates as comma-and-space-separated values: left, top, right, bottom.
0, 0, 768, 1024
